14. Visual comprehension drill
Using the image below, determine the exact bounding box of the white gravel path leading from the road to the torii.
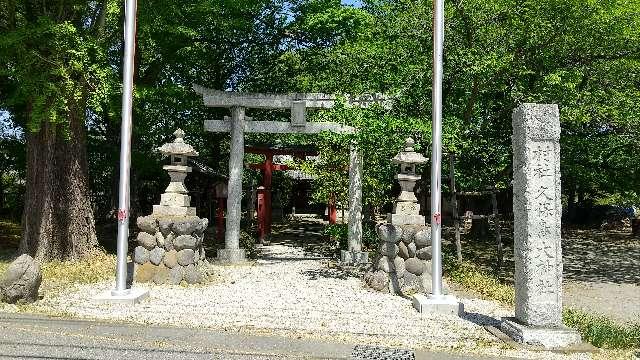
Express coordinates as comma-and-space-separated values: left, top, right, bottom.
5, 245, 588, 359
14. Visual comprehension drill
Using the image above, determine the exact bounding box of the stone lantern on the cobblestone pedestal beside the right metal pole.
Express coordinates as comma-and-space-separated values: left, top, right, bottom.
387, 138, 427, 225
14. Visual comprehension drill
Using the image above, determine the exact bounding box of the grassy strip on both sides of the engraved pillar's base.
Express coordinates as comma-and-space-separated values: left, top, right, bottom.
444, 254, 640, 349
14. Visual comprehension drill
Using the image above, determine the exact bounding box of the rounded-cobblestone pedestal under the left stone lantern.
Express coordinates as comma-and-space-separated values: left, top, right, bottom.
133, 215, 208, 285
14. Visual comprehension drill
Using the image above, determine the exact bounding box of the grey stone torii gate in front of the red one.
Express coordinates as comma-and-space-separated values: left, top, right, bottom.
193, 85, 390, 264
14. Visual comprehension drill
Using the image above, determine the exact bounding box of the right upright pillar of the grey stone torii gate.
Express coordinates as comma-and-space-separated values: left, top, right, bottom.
340, 145, 369, 264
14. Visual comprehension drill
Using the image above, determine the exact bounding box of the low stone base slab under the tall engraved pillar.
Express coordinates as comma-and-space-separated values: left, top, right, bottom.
500, 318, 582, 349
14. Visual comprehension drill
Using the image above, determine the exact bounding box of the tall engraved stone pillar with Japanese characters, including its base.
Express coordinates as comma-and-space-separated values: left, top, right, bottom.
501, 104, 580, 347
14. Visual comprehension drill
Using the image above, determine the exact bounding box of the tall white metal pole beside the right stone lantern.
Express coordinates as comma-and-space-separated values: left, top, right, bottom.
431, 0, 444, 297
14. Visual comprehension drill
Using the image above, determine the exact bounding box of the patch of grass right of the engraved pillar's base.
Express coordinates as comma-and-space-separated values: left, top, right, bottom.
562, 309, 640, 349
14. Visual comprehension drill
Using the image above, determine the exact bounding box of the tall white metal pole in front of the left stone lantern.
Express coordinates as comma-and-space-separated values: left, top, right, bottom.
111, 0, 137, 296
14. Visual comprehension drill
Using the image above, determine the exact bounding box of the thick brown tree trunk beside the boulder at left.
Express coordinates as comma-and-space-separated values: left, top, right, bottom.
20, 105, 98, 261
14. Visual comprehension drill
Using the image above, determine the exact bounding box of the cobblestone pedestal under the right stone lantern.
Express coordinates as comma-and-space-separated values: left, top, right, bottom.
365, 224, 431, 295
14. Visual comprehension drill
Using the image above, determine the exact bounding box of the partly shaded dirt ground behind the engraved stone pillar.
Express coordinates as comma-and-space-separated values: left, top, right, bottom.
444, 224, 640, 323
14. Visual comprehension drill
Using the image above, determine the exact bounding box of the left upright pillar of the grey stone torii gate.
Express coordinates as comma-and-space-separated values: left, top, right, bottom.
218, 106, 245, 262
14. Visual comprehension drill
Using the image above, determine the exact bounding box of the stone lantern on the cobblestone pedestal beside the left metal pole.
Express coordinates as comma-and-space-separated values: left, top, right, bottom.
153, 129, 198, 216
